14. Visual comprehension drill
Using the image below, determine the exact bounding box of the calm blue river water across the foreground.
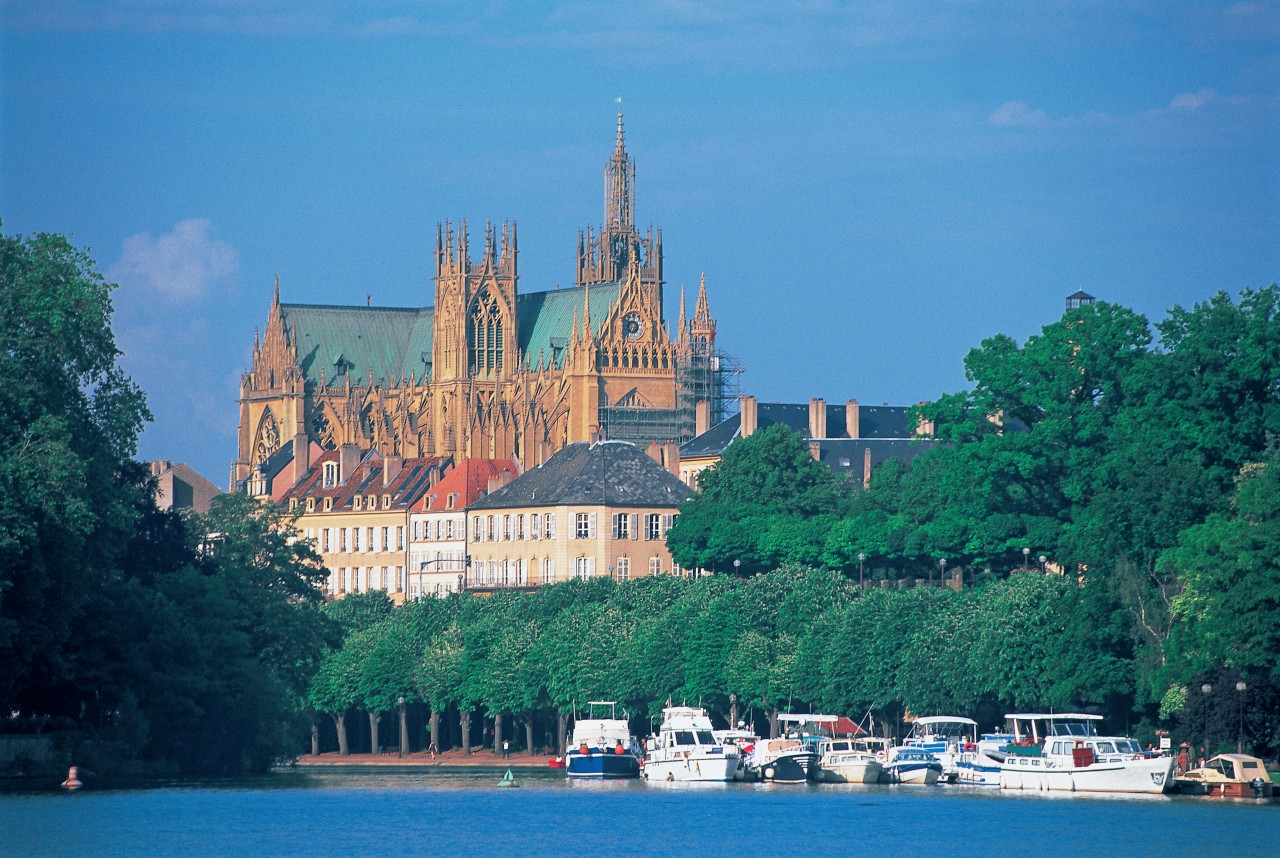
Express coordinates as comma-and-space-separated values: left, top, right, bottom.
0, 770, 1280, 858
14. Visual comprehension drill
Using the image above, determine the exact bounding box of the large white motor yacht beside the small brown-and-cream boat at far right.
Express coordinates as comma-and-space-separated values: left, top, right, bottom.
1000, 713, 1174, 794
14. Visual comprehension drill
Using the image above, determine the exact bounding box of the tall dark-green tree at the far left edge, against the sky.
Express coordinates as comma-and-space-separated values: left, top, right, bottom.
0, 233, 151, 713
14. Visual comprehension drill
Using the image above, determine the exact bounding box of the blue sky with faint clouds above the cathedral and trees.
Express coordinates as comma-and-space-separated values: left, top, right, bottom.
0, 0, 1280, 484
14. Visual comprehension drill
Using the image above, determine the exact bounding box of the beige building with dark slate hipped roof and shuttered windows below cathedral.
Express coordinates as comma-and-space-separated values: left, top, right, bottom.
465, 441, 692, 592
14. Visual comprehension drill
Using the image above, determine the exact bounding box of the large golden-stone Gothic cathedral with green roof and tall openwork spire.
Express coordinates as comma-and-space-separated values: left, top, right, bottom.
232, 113, 728, 494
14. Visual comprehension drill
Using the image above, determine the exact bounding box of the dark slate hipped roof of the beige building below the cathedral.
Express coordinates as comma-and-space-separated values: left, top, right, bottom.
471, 441, 694, 510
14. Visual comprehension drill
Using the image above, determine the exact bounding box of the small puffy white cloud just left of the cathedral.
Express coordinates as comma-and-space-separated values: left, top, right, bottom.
106, 218, 239, 301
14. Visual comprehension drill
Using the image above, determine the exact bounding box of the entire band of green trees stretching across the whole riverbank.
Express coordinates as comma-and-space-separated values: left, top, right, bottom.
0, 225, 1280, 772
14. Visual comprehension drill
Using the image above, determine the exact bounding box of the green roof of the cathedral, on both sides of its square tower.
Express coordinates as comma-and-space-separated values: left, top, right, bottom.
280, 283, 618, 385
